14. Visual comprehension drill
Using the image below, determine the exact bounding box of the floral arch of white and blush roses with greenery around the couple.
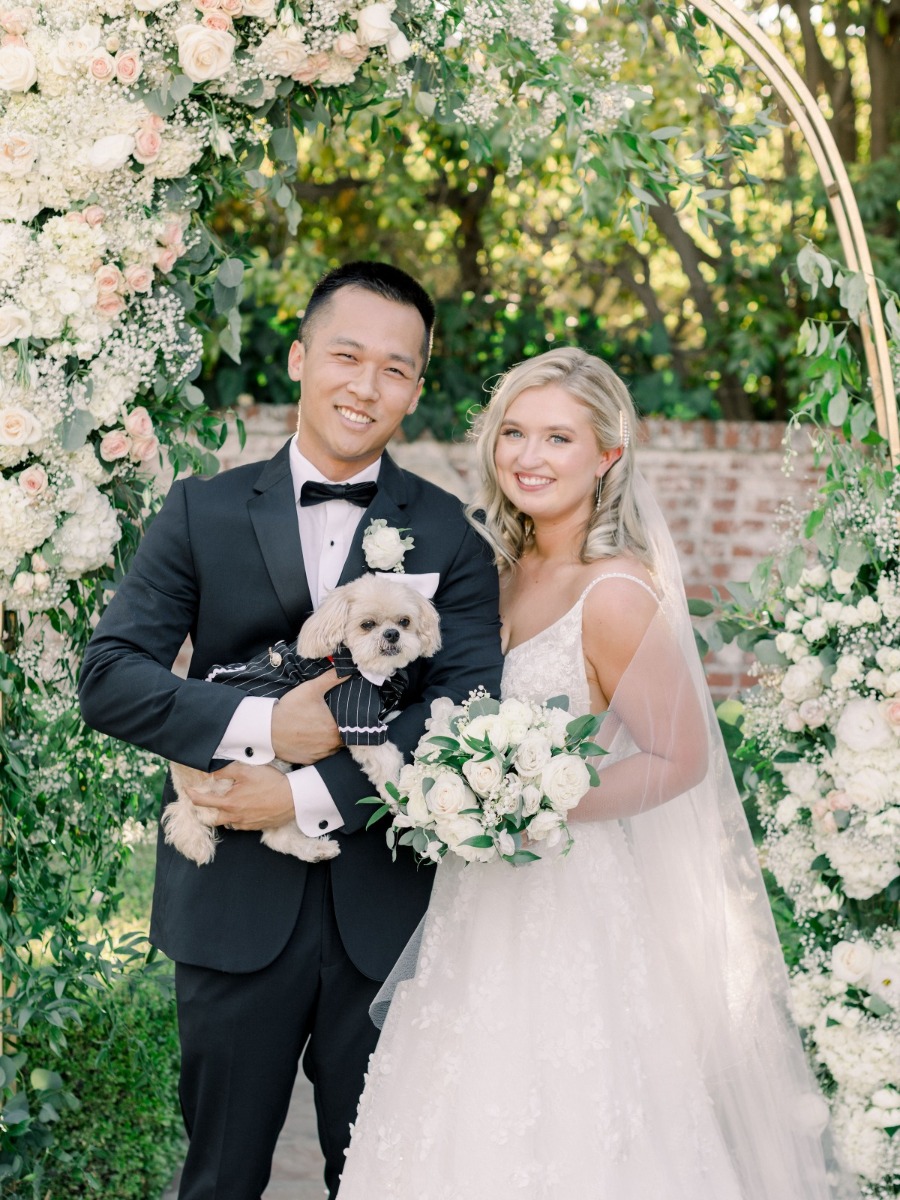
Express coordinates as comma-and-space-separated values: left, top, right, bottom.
0, 0, 900, 1196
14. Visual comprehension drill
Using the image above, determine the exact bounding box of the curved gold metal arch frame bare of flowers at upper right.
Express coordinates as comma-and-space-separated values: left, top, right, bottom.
689, 0, 900, 467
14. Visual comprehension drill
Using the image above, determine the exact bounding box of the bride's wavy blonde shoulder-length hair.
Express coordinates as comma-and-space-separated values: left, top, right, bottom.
467, 346, 653, 568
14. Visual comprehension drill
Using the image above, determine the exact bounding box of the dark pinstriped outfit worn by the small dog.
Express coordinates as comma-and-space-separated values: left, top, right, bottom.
206, 642, 409, 746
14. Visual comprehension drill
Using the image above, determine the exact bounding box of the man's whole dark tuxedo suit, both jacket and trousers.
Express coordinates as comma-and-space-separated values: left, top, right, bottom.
80, 445, 502, 1200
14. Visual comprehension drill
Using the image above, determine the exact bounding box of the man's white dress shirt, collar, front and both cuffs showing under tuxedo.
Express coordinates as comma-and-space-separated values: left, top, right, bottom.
215, 438, 382, 838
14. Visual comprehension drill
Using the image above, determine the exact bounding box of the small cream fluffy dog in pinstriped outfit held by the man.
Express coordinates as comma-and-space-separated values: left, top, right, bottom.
162, 575, 440, 865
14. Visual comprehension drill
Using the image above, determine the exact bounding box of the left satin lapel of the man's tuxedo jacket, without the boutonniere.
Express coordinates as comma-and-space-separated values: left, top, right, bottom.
247, 442, 312, 630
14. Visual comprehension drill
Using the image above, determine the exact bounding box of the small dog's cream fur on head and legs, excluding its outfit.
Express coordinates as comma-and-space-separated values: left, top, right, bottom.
162, 575, 440, 865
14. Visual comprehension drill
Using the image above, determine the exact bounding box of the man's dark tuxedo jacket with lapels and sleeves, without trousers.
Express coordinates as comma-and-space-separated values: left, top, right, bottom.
79, 443, 502, 979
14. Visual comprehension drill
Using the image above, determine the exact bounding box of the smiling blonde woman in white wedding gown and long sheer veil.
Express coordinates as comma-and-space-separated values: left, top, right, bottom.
341, 348, 842, 1200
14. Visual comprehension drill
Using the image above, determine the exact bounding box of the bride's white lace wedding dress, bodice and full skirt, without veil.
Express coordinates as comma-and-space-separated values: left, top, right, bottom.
341, 580, 763, 1200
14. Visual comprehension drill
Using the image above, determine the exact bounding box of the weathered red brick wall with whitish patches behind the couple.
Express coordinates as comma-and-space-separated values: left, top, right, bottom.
214, 407, 818, 696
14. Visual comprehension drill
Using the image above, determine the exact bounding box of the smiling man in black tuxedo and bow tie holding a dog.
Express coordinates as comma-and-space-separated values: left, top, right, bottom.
80, 263, 500, 1200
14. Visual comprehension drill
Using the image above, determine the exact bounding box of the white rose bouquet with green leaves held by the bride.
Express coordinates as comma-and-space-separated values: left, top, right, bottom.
361, 691, 604, 866
